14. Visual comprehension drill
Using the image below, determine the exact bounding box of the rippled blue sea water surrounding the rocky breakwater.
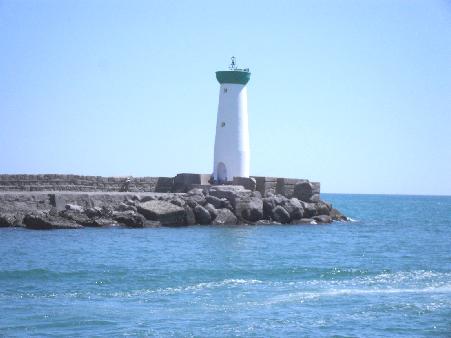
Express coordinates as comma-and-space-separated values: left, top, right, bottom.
0, 194, 451, 337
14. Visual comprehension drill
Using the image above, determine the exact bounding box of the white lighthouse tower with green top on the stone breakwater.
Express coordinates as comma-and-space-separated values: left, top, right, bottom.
213, 57, 251, 183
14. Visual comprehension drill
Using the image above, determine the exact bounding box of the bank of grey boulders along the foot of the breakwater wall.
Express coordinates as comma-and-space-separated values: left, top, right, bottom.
0, 185, 348, 230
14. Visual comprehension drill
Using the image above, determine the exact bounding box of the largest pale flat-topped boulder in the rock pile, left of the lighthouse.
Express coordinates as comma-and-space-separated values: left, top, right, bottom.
138, 201, 186, 226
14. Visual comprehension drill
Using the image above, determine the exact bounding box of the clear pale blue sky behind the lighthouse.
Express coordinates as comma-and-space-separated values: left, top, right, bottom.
0, 0, 451, 195
